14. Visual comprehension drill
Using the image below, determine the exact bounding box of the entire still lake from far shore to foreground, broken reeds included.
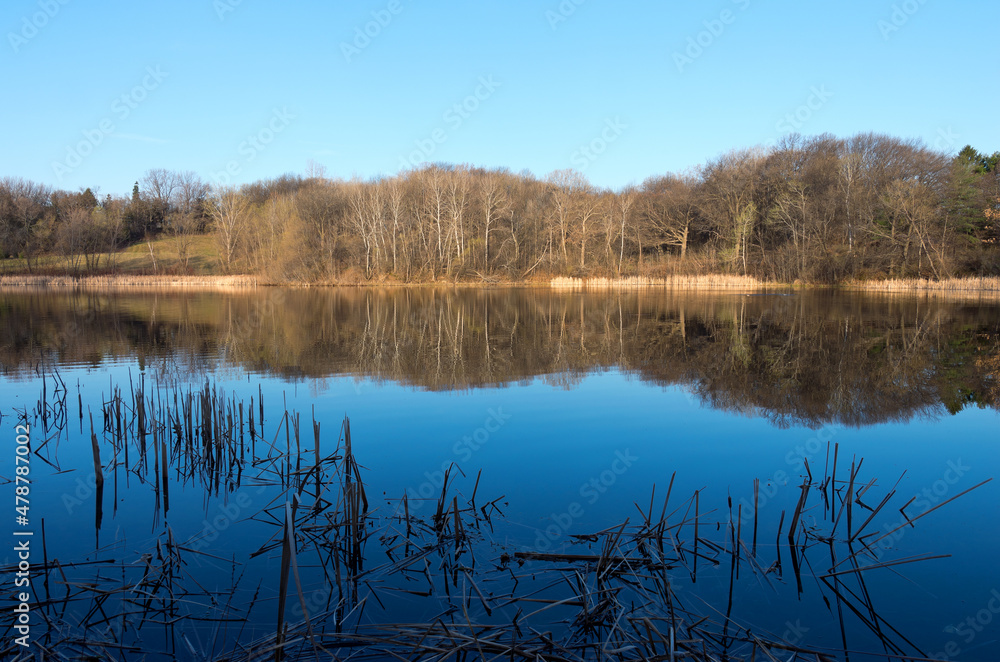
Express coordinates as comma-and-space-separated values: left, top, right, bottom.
0, 288, 1000, 661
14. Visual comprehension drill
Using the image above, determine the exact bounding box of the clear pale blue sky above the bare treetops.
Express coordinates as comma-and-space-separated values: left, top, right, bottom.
0, 0, 1000, 195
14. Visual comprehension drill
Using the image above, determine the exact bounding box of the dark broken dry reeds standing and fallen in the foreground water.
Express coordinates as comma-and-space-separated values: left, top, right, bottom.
9, 377, 982, 662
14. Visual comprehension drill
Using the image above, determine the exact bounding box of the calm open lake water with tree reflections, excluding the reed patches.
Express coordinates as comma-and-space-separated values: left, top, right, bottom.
0, 289, 1000, 660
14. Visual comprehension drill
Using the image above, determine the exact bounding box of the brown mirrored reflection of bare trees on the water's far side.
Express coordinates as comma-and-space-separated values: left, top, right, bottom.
0, 288, 1000, 425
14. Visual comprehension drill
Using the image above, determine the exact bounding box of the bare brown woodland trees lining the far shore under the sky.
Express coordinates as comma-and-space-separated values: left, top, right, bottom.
0, 133, 1000, 283
